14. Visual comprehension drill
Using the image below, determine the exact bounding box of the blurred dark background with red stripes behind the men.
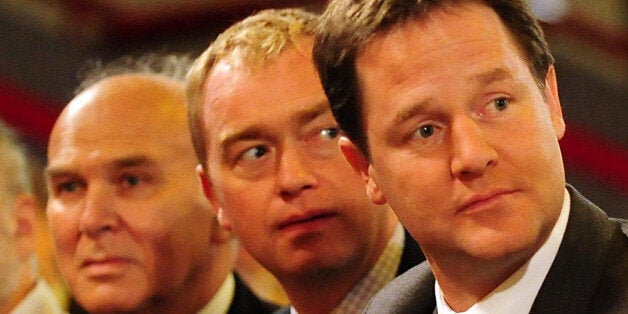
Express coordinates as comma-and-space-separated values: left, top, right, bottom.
0, 0, 628, 218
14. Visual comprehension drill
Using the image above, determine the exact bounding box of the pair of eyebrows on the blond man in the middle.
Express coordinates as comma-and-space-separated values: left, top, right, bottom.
218, 101, 331, 155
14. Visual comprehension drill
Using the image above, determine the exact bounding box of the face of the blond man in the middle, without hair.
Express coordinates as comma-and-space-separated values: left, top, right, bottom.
202, 40, 394, 280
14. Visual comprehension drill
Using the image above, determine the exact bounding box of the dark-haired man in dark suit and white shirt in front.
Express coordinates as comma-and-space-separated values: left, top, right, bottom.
314, 0, 628, 313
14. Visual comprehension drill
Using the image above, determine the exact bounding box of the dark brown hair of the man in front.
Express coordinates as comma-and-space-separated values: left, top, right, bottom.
313, 0, 554, 158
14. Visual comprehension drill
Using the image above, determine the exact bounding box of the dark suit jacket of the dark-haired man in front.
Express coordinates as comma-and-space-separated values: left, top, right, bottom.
366, 186, 628, 314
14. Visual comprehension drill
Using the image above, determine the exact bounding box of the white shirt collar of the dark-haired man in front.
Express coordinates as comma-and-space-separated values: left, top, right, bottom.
435, 189, 571, 314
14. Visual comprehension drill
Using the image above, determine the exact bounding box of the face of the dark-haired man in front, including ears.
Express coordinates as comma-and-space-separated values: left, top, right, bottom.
349, 3, 564, 262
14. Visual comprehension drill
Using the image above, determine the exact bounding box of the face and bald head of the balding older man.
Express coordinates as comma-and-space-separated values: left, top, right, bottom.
47, 76, 212, 311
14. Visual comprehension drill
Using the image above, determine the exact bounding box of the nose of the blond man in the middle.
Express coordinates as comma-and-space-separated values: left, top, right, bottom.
277, 143, 317, 196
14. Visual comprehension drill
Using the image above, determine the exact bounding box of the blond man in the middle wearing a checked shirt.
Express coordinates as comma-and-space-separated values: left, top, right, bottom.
188, 9, 423, 314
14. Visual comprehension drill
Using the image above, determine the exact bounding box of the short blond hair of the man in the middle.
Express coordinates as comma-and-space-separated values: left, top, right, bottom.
186, 9, 318, 169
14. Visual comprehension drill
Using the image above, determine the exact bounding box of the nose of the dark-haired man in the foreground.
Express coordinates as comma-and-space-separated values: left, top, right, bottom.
451, 118, 498, 178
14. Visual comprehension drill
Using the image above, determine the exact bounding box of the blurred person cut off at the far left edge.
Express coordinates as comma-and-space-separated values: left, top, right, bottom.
0, 121, 64, 314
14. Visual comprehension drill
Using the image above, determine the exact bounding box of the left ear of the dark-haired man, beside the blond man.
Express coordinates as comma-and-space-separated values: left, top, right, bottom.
338, 136, 386, 205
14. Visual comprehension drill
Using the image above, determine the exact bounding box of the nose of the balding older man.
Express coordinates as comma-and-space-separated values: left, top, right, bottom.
78, 184, 120, 238
